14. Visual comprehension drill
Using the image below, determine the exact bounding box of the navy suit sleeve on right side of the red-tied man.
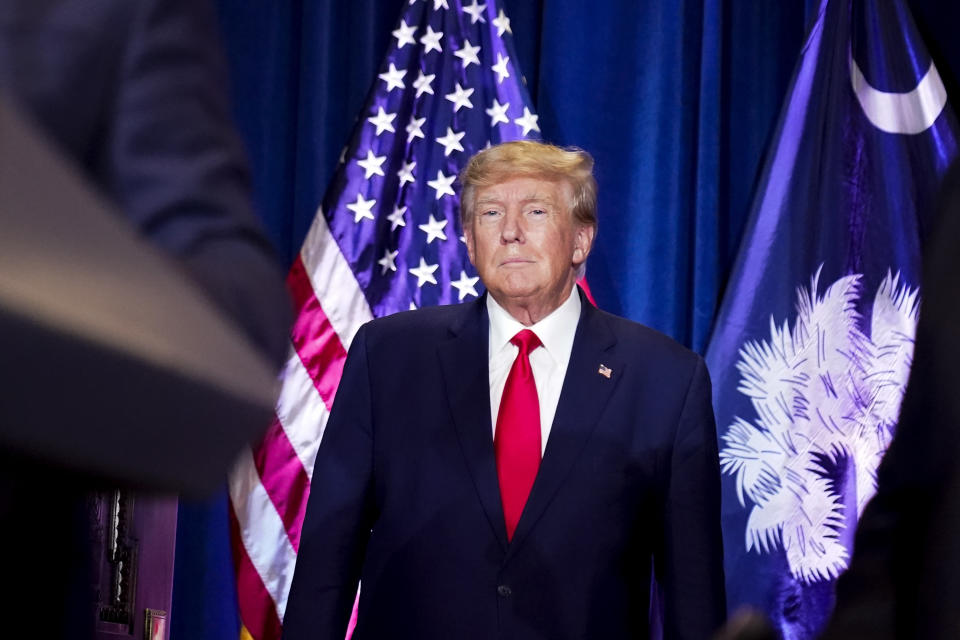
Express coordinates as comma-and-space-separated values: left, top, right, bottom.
654, 357, 726, 640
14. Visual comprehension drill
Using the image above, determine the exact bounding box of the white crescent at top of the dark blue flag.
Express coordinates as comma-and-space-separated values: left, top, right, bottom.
847, 52, 947, 134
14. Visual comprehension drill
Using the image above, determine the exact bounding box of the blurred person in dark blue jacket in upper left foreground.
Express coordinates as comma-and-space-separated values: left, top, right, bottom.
0, 0, 290, 356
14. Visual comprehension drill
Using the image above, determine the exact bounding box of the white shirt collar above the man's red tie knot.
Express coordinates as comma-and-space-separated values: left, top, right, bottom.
487, 285, 581, 360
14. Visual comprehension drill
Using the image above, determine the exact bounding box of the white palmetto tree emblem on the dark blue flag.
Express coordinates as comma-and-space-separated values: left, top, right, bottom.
720, 270, 918, 583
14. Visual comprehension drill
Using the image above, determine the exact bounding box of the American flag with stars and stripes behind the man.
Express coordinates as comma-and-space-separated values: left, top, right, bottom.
230, 0, 540, 640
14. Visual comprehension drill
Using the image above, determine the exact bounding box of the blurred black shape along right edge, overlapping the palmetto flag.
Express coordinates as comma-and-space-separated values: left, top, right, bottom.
821, 164, 960, 640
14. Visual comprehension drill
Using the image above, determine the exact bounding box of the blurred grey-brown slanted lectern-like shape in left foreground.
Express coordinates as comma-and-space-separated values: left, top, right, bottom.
0, 100, 275, 493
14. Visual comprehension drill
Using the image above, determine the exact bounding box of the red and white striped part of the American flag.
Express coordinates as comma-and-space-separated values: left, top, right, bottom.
230, 211, 373, 640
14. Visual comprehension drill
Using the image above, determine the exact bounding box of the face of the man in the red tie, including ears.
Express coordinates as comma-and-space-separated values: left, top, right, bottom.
464, 177, 594, 324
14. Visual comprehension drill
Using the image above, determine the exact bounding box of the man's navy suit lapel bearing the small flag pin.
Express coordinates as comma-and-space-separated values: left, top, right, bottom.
510, 296, 624, 560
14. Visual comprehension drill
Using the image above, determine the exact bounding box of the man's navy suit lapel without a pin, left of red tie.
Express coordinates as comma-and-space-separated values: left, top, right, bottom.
438, 296, 507, 551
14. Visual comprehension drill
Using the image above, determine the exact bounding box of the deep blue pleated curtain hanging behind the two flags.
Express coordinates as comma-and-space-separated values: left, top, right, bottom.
171, 0, 960, 640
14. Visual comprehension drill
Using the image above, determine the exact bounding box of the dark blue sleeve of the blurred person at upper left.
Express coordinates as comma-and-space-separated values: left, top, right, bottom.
107, 0, 291, 367
